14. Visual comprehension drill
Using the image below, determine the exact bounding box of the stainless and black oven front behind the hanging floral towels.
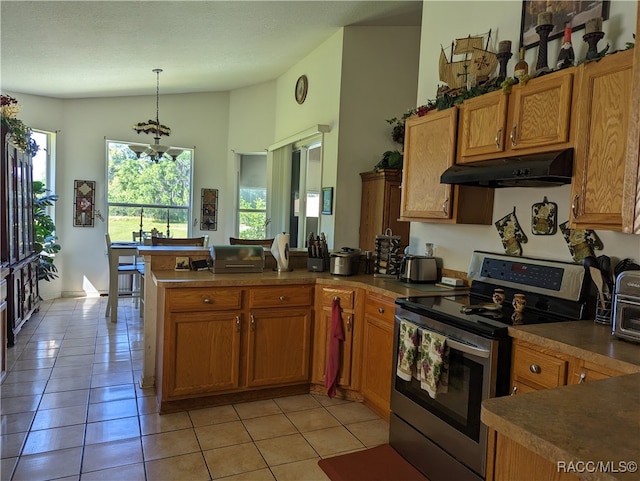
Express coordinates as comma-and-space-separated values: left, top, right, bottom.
391, 308, 498, 477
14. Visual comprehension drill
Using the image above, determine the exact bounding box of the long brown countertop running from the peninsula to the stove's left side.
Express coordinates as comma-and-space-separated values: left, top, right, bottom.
153, 269, 468, 298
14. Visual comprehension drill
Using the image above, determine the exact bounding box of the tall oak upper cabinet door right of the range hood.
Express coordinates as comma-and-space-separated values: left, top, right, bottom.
571, 50, 633, 230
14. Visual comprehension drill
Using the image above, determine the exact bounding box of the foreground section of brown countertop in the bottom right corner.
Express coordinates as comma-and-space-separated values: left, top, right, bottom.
481, 373, 640, 480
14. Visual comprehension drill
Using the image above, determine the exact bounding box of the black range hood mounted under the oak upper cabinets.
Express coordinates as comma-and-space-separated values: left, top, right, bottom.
440, 149, 573, 187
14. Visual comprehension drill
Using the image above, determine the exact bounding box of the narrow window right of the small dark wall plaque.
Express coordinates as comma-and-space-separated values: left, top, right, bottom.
238, 155, 269, 239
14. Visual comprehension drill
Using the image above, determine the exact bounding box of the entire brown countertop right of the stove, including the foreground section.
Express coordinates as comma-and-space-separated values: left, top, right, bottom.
481, 321, 640, 480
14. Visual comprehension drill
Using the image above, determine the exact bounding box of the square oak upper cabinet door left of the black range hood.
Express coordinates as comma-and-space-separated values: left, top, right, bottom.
400, 107, 458, 220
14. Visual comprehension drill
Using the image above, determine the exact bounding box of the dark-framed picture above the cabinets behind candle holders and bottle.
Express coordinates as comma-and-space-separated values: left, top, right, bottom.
520, 0, 609, 49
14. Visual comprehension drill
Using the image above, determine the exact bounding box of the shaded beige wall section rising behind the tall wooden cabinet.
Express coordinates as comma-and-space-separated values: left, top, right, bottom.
334, 27, 420, 248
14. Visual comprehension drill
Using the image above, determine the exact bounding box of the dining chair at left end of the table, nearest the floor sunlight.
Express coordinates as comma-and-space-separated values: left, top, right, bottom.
105, 233, 144, 321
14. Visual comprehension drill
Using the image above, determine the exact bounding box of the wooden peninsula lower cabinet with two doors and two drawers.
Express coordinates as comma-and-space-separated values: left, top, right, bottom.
156, 285, 313, 412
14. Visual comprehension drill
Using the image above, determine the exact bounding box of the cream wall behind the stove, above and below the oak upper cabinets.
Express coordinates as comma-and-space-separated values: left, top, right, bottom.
410, 0, 640, 271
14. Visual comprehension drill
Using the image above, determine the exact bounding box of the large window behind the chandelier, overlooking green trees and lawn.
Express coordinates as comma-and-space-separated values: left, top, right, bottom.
107, 140, 194, 241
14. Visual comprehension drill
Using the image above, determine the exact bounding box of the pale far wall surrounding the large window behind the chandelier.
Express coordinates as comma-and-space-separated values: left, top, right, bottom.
13, 88, 234, 297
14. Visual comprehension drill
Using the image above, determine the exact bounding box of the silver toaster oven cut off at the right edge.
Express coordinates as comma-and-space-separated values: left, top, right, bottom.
613, 271, 640, 342
